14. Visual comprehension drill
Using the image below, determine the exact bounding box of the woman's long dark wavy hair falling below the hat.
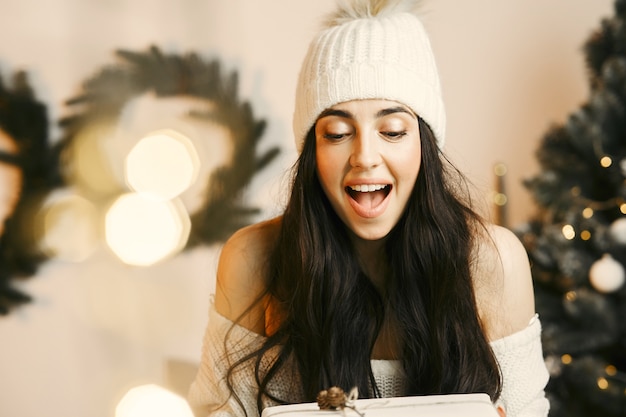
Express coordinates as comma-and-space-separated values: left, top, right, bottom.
224, 118, 501, 412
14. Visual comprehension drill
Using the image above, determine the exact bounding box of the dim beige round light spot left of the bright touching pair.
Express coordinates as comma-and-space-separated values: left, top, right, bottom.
36, 192, 99, 262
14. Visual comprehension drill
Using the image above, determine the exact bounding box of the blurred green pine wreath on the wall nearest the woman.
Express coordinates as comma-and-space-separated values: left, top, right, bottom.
60, 46, 279, 248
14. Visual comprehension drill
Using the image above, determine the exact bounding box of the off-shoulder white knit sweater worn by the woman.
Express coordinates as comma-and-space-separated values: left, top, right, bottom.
188, 306, 549, 417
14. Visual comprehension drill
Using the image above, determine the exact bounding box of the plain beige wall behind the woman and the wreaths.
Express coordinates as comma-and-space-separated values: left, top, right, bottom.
0, 0, 612, 417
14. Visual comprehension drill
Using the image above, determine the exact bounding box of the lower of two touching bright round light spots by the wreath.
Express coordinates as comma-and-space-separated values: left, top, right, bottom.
105, 193, 191, 266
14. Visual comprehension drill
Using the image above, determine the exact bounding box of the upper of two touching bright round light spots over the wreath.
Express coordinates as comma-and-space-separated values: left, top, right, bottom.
126, 129, 200, 200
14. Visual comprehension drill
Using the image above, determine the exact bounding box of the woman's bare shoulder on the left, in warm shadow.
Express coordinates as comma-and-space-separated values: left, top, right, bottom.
215, 217, 281, 334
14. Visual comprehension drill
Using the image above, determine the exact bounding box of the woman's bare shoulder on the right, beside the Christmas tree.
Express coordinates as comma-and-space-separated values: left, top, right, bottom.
474, 225, 535, 340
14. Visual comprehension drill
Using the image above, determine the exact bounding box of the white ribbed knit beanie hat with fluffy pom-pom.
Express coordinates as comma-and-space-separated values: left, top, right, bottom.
293, 0, 446, 152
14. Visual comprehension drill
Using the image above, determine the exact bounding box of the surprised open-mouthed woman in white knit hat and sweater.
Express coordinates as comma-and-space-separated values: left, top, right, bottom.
189, 0, 548, 417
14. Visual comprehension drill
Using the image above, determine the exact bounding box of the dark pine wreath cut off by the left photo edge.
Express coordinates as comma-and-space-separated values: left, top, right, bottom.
0, 71, 63, 315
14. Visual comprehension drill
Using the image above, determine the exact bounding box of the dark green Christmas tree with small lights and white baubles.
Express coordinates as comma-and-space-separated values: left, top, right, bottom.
518, 0, 626, 417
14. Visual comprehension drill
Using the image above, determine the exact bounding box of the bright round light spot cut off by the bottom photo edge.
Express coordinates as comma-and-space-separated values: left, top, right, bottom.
115, 384, 193, 417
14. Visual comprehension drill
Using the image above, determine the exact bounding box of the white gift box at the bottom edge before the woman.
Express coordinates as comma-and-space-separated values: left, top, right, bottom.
261, 394, 499, 417
